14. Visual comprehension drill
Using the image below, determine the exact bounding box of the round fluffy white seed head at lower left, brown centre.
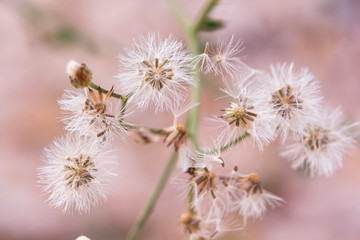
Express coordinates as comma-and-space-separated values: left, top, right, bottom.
39, 134, 114, 213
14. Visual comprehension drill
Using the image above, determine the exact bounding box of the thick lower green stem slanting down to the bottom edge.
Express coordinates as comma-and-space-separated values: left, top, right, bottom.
126, 152, 177, 240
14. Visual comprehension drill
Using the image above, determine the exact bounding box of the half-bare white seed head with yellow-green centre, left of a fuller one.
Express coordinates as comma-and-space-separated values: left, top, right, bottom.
210, 80, 275, 150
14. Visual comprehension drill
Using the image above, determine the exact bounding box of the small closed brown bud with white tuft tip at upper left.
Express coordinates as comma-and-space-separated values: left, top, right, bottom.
66, 60, 92, 88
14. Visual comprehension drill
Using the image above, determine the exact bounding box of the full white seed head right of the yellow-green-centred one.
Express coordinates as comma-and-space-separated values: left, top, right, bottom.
263, 63, 322, 139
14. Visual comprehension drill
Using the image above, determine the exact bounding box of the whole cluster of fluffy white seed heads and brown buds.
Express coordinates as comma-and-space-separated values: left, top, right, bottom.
39, 34, 357, 240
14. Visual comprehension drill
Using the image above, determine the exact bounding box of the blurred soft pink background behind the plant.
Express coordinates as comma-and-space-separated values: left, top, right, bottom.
0, 0, 360, 240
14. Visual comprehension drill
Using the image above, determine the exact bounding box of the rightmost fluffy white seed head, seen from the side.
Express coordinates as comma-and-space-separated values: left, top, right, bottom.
282, 108, 358, 176
